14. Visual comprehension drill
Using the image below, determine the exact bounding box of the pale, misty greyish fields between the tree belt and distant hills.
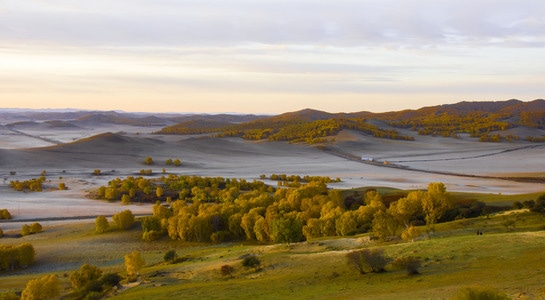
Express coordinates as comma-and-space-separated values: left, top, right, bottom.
0, 124, 545, 230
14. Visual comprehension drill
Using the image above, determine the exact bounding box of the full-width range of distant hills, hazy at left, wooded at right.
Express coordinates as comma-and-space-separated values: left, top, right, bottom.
0, 99, 545, 143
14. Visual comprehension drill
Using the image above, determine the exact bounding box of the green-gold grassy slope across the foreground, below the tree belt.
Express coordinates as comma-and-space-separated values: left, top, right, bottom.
0, 206, 545, 299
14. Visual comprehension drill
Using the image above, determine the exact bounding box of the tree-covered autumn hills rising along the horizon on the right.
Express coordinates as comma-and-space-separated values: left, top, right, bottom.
158, 100, 545, 144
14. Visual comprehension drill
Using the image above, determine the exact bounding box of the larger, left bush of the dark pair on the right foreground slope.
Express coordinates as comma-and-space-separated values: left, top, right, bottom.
346, 249, 390, 274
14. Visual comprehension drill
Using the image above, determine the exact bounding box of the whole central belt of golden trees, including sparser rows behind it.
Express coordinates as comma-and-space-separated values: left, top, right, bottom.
92, 175, 506, 243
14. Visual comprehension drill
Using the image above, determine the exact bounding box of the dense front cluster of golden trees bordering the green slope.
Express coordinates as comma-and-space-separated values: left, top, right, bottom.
130, 176, 454, 243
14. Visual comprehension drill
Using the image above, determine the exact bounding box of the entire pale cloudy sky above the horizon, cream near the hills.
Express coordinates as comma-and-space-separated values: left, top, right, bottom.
0, 0, 545, 114
